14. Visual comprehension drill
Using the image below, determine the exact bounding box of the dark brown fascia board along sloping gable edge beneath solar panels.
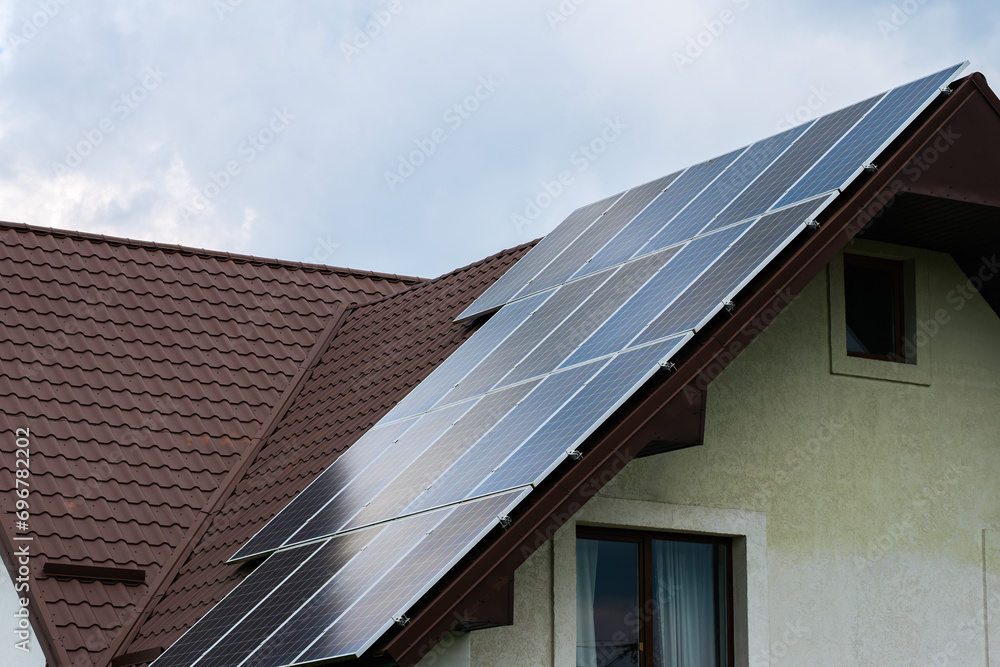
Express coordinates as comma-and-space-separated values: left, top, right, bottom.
380, 73, 984, 667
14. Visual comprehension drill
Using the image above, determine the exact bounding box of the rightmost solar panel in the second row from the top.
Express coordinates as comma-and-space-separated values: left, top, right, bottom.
636, 195, 829, 345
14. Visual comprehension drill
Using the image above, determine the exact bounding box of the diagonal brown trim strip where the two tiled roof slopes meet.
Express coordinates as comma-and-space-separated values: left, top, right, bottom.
100, 304, 348, 667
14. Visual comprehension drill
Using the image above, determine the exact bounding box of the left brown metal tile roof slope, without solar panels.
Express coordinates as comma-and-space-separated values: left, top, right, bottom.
0, 223, 420, 666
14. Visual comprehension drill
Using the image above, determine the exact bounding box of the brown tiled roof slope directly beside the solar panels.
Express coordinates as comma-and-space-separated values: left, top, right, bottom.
117, 239, 531, 655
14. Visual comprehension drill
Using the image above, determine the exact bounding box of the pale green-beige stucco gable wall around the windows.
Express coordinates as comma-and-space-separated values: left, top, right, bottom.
471, 247, 1000, 667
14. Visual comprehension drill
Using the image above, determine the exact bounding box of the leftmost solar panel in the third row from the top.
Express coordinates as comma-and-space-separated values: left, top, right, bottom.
231, 418, 417, 560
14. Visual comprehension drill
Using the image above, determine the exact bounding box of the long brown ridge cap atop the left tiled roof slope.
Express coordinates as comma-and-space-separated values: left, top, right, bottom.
0, 220, 428, 284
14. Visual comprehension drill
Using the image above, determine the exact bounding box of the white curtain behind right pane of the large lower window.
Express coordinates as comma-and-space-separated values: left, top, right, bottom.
648, 540, 719, 667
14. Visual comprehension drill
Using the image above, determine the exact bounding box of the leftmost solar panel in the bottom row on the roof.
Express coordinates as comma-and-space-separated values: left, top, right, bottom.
150, 544, 323, 667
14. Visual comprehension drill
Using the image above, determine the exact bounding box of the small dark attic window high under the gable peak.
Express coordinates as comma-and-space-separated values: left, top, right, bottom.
844, 255, 906, 363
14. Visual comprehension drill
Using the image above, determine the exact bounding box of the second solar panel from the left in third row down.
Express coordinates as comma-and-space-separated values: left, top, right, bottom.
286, 399, 476, 544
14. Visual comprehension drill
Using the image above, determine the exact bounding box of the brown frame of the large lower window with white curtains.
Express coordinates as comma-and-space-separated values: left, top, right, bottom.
576, 526, 736, 667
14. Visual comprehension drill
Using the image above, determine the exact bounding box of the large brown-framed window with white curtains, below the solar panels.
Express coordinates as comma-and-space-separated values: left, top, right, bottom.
576, 528, 733, 667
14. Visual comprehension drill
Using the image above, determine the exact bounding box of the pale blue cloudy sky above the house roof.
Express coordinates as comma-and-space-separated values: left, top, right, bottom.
0, 0, 1000, 277
